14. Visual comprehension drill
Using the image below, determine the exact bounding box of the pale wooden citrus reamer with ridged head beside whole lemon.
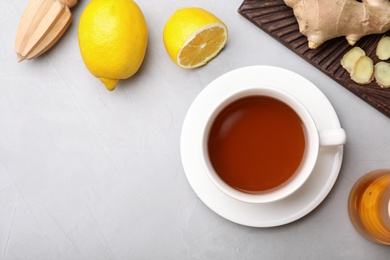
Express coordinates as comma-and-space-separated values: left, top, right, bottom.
15, 0, 77, 62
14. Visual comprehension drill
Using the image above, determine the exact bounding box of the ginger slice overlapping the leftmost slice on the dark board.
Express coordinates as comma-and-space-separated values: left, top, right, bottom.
351, 56, 374, 84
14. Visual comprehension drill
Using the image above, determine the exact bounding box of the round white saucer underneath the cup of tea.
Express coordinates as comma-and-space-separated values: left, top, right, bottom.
180, 66, 343, 227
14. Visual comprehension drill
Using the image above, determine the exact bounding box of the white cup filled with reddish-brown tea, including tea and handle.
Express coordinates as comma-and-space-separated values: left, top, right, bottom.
201, 86, 346, 203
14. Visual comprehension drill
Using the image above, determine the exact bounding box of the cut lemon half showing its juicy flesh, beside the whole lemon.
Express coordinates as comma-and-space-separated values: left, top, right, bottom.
163, 7, 228, 69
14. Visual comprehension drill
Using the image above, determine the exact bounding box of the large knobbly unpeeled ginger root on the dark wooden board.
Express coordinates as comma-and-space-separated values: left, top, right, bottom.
284, 0, 390, 49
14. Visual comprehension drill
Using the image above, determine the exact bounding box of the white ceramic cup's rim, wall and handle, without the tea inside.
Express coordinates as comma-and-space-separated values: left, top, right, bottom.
201, 86, 346, 203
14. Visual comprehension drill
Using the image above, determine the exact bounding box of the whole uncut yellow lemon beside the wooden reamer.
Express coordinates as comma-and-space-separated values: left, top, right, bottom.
78, 0, 148, 91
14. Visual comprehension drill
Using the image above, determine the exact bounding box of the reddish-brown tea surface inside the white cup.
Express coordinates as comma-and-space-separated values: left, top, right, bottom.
208, 96, 305, 194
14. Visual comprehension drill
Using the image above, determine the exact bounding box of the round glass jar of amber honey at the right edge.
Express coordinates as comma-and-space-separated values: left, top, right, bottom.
348, 169, 390, 245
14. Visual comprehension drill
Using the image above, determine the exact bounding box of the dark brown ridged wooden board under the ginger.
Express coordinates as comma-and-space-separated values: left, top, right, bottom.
238, 0, 390, 117
